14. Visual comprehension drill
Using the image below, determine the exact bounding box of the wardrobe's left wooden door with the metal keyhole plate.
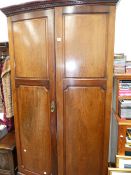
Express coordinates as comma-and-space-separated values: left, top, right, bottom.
8, 9, 57, 175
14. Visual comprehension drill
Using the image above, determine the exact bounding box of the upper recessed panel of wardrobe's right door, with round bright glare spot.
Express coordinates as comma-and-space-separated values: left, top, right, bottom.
64, 14, 107, 78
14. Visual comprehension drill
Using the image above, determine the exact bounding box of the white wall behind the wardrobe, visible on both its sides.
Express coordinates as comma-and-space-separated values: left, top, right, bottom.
0, 0, 131, 60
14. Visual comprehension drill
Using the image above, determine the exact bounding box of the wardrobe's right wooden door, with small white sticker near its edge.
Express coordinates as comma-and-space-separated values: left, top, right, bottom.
55, 5, 115, 175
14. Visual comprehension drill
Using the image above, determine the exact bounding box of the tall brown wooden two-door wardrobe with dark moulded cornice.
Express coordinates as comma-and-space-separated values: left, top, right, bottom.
2, 0, 117, 175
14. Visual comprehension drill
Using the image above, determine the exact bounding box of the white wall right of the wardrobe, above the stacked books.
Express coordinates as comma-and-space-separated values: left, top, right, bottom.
115, 0, 131, 60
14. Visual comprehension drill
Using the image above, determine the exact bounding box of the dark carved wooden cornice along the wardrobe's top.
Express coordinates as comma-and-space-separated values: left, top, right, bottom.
1, 0, 119, 16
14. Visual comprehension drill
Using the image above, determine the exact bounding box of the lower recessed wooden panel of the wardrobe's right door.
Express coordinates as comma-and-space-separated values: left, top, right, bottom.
64, 87, 105, 175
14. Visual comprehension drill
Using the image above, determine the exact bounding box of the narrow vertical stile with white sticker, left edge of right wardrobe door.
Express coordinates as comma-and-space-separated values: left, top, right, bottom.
55, 7, 64, 175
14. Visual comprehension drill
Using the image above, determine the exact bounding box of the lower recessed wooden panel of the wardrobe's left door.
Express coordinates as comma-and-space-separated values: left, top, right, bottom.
17, 86, 51, 174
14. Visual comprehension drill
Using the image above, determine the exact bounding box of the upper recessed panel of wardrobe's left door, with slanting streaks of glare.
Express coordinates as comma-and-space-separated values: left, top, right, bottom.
13, 18, 48, 78
